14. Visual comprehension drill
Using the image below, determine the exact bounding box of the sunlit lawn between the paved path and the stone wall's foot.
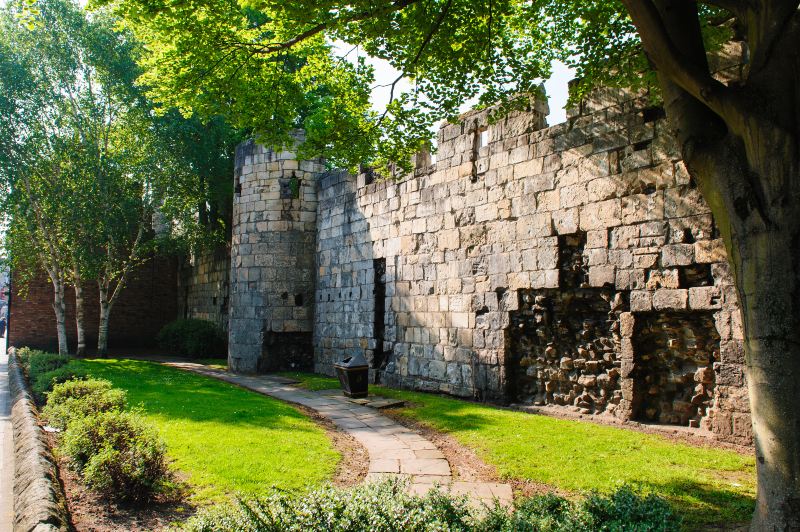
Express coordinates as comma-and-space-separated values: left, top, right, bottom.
280, 373, 755, 527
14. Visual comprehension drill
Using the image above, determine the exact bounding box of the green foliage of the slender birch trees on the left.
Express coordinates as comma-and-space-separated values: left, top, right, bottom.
0, 0, 240, 296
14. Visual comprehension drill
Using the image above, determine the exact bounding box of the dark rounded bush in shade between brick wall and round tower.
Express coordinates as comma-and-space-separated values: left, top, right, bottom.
156, 319, 225, 358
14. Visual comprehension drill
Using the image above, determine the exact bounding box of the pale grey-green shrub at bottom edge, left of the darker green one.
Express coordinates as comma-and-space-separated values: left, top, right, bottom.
185, 481, 474, 532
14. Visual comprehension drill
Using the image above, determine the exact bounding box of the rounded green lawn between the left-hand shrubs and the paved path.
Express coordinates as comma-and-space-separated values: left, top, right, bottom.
69, 359, 340, 504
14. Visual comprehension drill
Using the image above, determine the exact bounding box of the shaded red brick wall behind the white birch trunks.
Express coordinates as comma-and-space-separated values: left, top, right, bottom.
8, 258, 178, 352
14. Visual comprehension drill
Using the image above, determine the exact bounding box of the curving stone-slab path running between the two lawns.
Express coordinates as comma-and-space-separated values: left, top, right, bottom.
165, 362, 513, 505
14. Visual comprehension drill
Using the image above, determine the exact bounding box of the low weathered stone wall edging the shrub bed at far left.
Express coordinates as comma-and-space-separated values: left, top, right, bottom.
8, 348, 69, 532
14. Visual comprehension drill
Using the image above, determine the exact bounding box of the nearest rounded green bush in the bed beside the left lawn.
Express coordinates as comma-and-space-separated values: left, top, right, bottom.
59, 410, 167, 502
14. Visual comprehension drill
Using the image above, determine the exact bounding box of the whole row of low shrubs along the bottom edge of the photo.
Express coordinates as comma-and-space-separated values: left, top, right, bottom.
184, 481, 680, 532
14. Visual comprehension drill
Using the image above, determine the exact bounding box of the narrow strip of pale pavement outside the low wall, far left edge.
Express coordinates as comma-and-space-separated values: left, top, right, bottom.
0, 338, 14, 530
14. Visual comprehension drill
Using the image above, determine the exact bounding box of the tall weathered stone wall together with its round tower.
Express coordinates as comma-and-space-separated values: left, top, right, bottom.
183, 85, 751, 443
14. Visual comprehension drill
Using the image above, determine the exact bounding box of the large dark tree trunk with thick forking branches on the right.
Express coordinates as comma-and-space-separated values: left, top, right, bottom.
623, 0, 800, 531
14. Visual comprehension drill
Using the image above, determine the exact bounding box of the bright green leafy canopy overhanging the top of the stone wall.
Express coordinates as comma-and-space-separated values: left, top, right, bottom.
96, 0, 730, 172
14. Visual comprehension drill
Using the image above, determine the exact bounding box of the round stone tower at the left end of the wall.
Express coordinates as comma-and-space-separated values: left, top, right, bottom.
228, 133, 323, 372
